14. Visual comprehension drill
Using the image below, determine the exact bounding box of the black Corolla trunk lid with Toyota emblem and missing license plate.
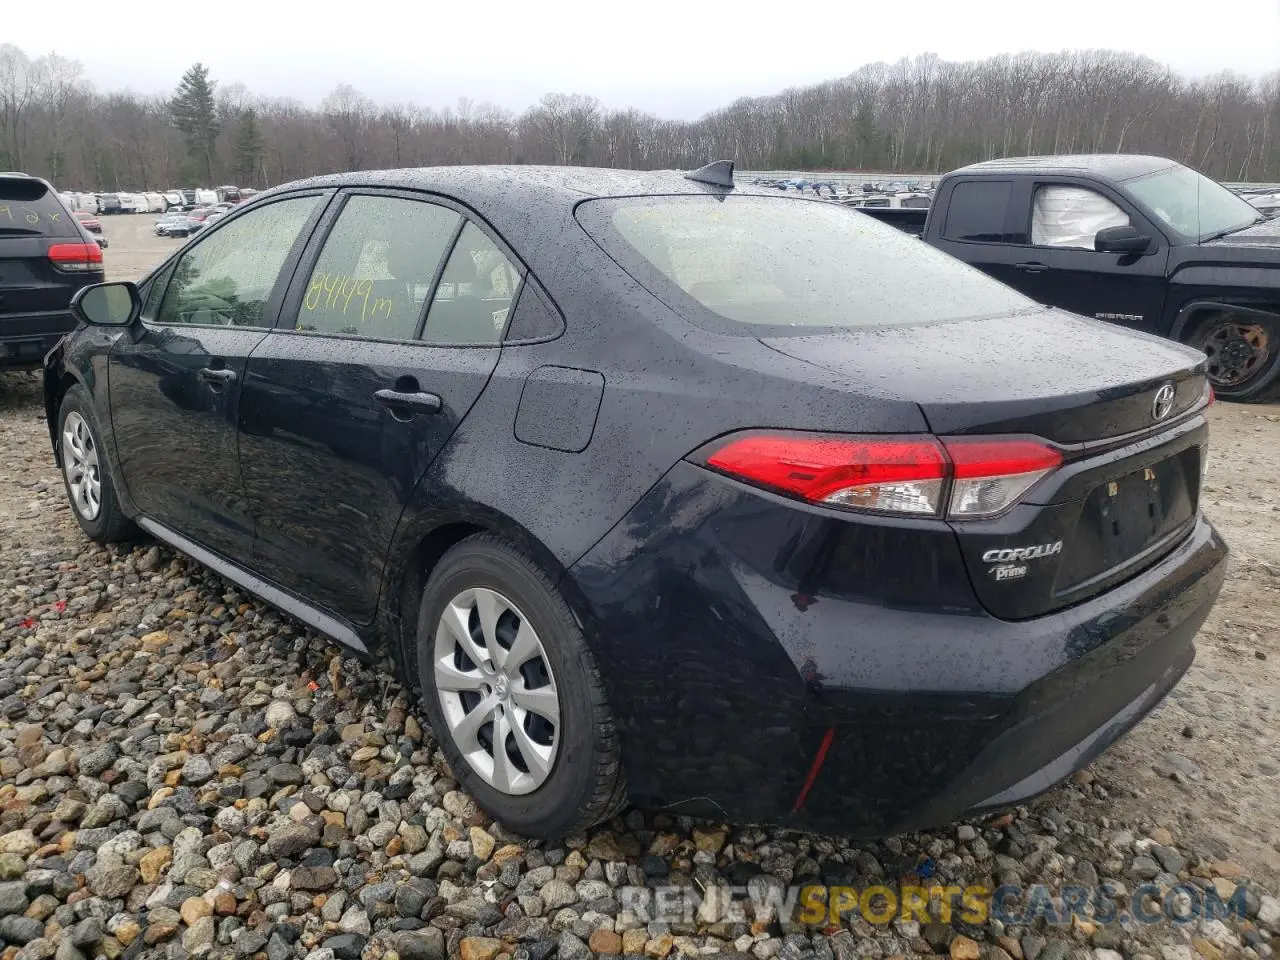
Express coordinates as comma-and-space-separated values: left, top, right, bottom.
764, 310, 1208, 620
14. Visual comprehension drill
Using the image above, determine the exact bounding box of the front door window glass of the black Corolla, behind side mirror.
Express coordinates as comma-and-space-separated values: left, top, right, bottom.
156, 197, 320, 326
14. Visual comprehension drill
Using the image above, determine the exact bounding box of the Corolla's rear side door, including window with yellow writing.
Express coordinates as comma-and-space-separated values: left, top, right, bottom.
239, 191, 522, 623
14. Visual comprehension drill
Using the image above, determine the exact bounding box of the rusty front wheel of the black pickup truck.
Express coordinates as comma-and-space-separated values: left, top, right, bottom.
1187, 314, 1280, 403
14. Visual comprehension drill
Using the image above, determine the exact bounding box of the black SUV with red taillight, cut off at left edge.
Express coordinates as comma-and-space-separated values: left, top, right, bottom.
0, 173, 102, 370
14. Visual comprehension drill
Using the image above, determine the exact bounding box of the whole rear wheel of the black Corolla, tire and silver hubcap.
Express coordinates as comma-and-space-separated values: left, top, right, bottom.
416, 534, 626, 838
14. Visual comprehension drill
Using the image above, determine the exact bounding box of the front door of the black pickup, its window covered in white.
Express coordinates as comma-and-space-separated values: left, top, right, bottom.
1014, 180, 1169, 330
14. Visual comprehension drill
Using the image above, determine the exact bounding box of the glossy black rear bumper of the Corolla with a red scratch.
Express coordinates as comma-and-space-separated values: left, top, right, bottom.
566, 465, 1226, 836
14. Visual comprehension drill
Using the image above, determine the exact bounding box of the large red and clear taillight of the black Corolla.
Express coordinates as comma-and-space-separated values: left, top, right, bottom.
701, 430, 1062, 520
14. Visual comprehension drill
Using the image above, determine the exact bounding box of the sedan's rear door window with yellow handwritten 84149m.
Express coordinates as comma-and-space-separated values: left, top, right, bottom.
294, 196, 461, 340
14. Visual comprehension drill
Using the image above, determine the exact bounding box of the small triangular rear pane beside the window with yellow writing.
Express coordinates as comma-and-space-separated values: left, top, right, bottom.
422, 223, 521, 343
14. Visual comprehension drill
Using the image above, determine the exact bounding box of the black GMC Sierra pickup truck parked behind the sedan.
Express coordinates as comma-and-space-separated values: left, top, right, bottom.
863, 154, 1280, 402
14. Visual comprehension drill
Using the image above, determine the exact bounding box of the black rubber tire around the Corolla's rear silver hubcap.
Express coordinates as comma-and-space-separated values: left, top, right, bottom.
417, 544, 596, 836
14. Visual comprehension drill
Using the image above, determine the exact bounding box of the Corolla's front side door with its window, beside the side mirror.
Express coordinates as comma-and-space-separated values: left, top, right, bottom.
108, 193, 323, 562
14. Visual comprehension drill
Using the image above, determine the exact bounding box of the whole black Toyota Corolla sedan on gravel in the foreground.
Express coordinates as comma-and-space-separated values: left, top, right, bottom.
45, 165, 1226, 837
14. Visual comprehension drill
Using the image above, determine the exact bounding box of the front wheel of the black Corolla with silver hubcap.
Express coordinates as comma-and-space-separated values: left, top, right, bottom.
58, 384, 138, 544
